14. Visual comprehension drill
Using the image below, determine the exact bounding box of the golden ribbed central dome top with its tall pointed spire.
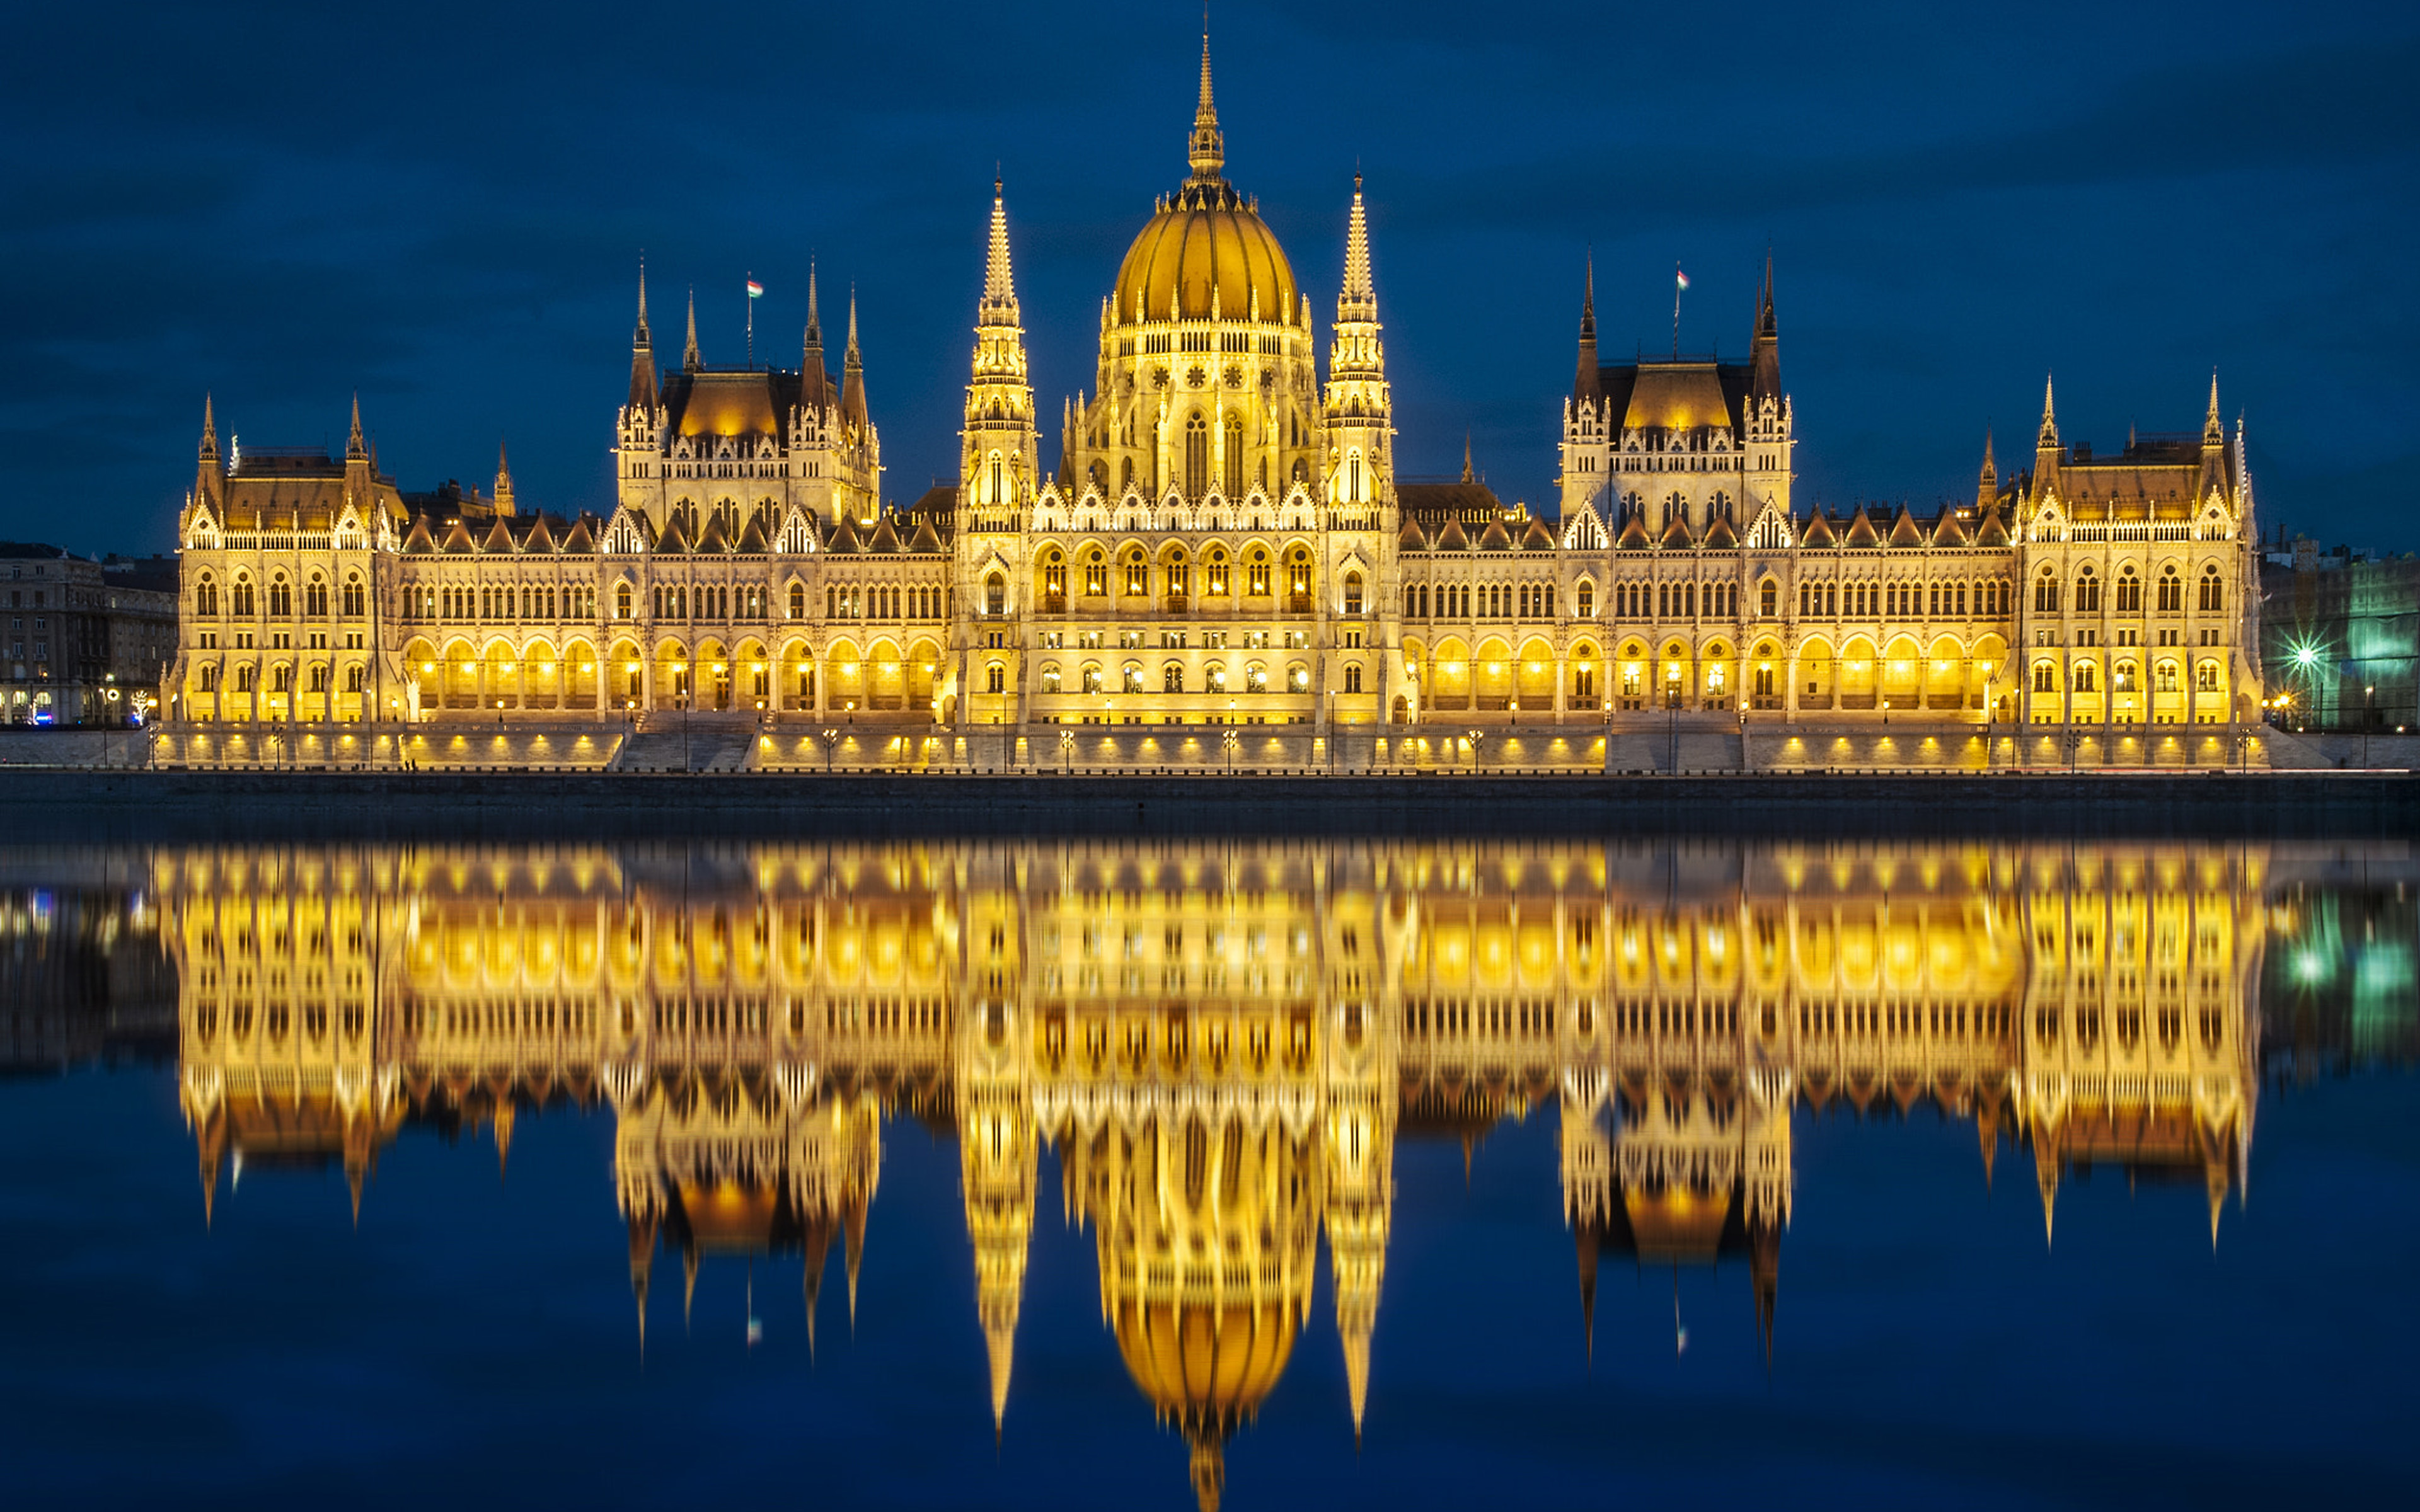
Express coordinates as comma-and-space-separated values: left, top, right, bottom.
1111, 37, 1297, 324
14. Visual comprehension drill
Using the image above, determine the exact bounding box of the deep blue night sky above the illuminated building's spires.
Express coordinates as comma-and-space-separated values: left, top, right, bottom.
0, 0, 2420, 552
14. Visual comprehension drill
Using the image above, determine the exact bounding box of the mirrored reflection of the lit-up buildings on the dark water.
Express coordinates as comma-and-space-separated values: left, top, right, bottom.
0, 842, 2420, 1507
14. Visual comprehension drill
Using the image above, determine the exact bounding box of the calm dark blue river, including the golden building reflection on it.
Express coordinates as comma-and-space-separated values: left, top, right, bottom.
0, 839, 2420, 1509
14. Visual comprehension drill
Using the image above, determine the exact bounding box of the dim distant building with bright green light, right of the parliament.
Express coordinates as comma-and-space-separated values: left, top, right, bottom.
2261, 537, 2420, 731
